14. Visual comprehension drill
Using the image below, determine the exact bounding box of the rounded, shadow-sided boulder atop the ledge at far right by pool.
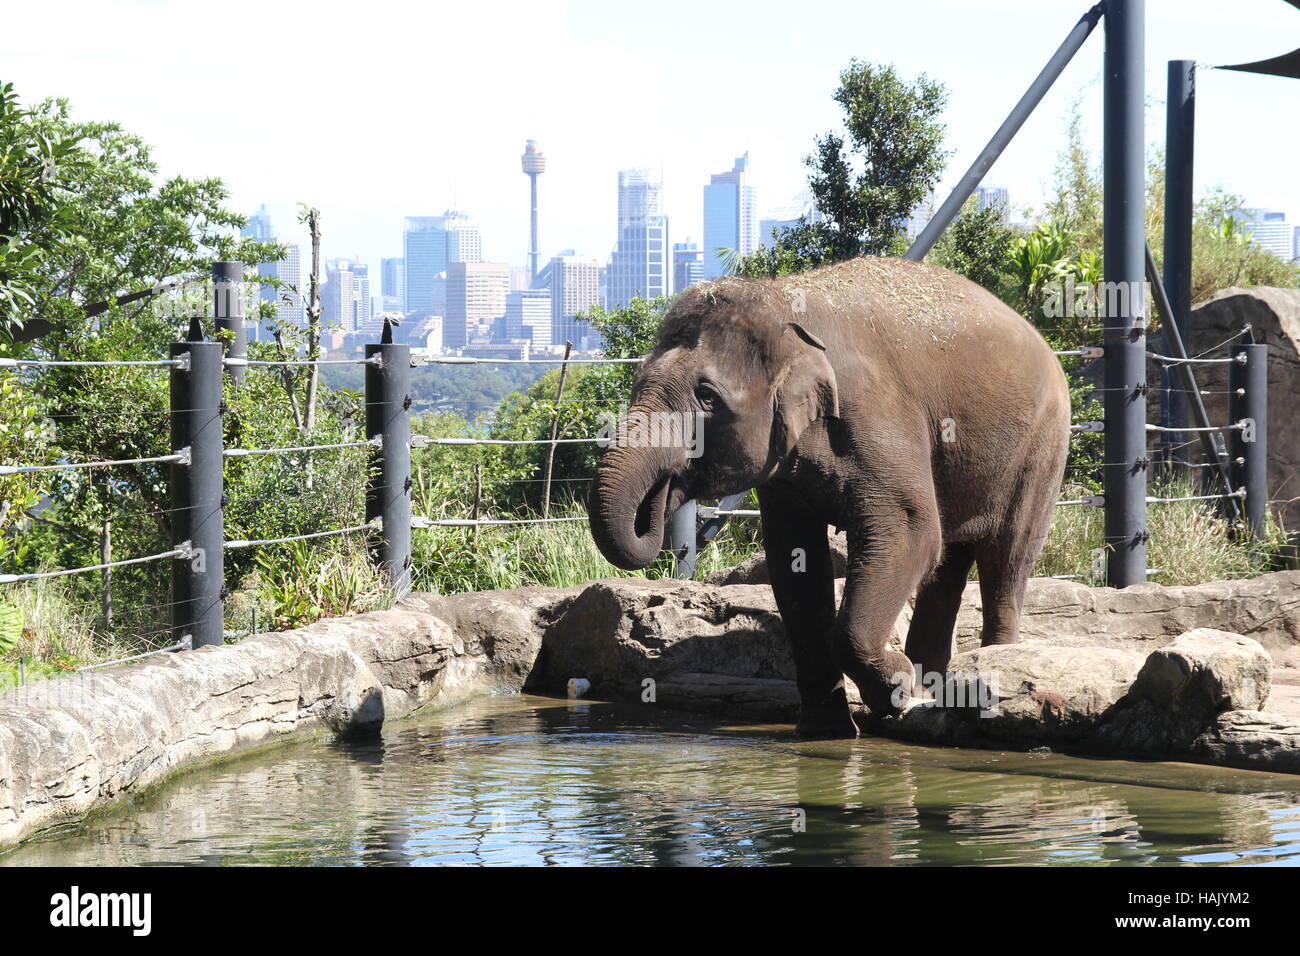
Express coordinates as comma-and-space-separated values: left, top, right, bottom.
1131, 627, 1273, 722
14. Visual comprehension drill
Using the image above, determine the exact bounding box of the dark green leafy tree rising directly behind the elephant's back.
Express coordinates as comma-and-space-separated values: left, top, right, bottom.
736, 60, 948, 276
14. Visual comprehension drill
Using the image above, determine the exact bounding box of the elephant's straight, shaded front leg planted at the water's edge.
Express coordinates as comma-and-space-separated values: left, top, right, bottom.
758, 485, 858, 737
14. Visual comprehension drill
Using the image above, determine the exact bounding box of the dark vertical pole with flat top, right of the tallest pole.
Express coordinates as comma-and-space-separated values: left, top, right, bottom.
1161, 60, 1196, 442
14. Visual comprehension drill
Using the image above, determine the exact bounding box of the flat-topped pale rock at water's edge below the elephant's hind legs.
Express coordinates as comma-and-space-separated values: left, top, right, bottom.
881, 643, 1143, 745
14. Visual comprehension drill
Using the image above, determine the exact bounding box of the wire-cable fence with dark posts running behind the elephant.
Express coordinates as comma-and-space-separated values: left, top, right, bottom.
0, 299, 1262, 666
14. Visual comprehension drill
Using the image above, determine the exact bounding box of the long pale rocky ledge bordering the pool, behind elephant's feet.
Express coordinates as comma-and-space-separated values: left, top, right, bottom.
0, 568, 1300, 845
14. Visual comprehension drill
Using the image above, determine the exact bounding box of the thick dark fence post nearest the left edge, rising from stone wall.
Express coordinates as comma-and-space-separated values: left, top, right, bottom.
169, 319, 226, 648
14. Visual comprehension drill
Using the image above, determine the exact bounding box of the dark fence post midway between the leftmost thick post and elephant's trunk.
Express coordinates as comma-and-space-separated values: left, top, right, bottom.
365, 323, 411, 598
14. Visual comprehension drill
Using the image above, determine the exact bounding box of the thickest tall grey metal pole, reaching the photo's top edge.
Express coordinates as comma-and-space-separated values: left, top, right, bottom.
1102, 0, 1149, 588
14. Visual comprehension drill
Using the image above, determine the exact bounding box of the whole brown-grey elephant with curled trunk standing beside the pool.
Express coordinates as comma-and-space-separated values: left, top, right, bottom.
589, 259, 1070, 736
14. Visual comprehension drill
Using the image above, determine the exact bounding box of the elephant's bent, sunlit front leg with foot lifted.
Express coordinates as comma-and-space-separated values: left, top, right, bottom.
833, 506, 941, 715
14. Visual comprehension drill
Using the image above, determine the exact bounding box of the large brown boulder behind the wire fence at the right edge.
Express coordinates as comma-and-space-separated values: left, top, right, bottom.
1187, 286, 1300, 533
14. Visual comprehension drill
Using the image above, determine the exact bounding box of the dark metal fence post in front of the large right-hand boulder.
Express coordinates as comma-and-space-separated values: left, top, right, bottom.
1229, 345, 1269, 537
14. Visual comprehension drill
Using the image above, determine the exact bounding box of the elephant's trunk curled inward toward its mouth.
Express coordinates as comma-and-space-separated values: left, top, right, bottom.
588, 445, 686, 571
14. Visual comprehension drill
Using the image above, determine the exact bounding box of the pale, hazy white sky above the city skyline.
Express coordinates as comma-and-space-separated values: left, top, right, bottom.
0, 0, 1300, 278
